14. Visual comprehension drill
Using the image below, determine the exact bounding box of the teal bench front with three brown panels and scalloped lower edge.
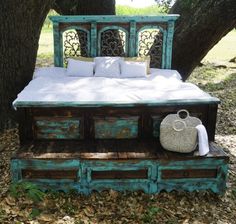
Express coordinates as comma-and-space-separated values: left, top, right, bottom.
11, 146, 228, 194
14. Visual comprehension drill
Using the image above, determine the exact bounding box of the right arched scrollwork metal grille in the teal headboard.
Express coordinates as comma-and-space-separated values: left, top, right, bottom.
138, 29, 163, 68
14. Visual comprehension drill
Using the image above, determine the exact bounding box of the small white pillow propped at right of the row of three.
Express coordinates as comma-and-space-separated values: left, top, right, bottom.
120, 61, 147, 78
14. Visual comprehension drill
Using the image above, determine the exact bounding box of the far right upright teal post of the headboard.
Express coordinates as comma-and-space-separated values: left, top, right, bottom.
165, 20, 175, 69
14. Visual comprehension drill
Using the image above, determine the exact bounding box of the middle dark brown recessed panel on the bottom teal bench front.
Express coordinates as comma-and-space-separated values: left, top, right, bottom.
91, 169, 148, 180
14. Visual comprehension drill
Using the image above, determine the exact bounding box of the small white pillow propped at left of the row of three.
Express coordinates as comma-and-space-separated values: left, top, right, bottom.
67, 58, 94, 77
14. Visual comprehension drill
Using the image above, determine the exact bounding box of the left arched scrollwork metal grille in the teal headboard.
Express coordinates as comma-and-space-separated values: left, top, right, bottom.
63, 30, 89, 64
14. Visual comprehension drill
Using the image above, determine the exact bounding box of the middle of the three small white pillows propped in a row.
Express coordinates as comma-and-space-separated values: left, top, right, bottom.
94, 57, 122, 77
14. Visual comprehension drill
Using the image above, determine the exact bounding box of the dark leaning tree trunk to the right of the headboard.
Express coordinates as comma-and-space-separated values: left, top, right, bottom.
169, 0, 236, 80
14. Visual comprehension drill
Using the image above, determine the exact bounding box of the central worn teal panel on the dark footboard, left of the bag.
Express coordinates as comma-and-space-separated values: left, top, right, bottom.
94, 117, 138, 139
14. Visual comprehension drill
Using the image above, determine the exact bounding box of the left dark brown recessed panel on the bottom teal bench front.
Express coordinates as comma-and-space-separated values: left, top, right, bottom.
21, 169, 78, 181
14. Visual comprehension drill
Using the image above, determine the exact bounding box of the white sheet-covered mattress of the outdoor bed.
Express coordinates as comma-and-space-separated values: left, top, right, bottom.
13, 68, 217, 108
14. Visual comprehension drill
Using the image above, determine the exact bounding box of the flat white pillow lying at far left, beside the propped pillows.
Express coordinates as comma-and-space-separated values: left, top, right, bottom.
33, 67, 66, 79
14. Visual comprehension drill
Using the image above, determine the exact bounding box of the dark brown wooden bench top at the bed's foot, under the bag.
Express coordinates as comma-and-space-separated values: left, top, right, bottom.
13, 139, 229, 161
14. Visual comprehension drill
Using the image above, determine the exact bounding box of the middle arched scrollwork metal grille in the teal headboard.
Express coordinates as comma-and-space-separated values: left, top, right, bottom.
100, 30, 127, 56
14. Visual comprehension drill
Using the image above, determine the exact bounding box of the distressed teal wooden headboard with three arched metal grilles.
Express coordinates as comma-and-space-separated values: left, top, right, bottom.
50, 15, 179, 69
